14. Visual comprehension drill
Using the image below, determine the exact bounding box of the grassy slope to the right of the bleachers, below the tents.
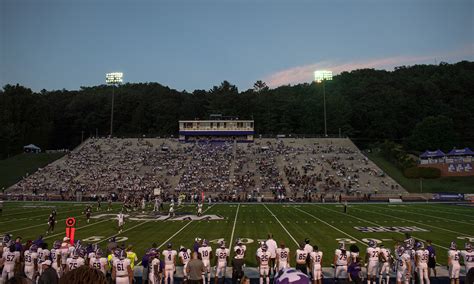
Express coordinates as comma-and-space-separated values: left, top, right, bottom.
367, 153, 474, 193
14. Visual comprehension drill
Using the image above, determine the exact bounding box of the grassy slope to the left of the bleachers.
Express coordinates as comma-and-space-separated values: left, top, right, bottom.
0, 153, 64, 190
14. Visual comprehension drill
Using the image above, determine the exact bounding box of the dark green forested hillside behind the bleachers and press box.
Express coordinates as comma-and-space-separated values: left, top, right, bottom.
0, 61, 474, 158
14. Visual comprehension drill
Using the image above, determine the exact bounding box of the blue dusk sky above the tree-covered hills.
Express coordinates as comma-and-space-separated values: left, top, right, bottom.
0, 0, 474, 91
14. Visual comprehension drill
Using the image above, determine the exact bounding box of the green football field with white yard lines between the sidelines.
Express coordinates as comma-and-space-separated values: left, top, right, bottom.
0, 202, 474, 266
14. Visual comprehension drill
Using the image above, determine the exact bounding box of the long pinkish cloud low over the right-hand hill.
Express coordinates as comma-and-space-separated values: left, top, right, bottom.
264, 44, 474, 88
